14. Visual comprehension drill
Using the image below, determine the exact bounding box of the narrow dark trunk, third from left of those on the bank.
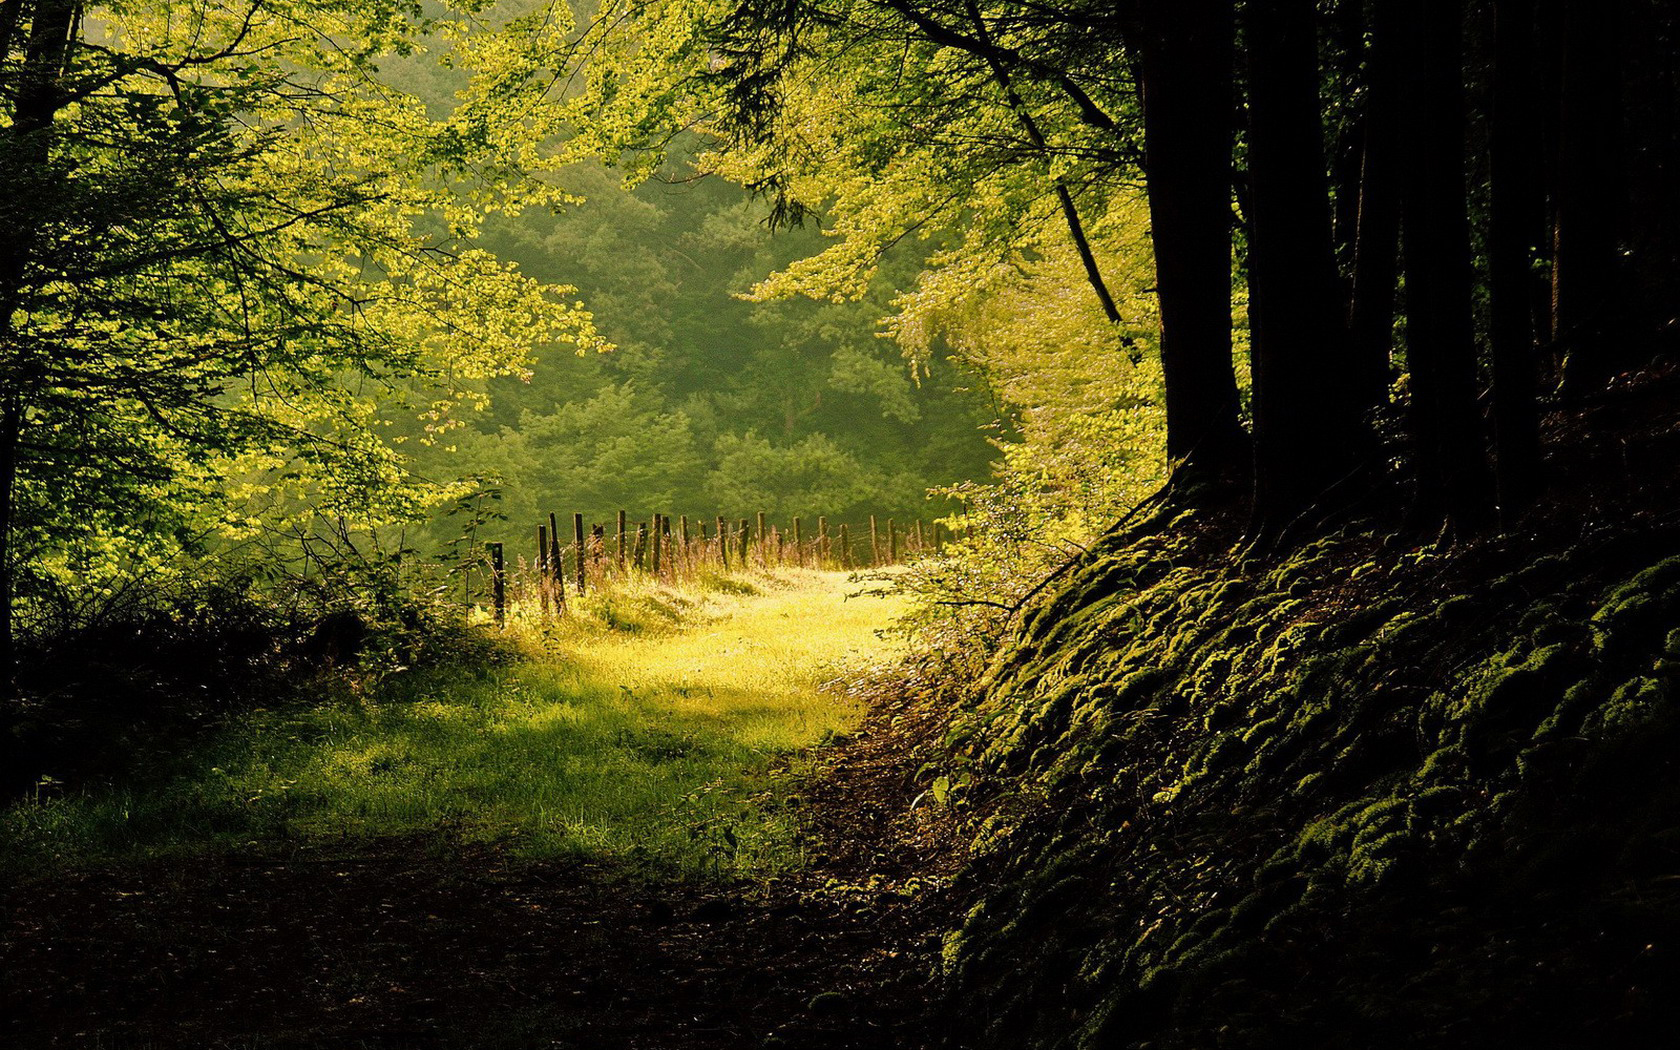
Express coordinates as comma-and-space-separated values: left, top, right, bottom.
1347, 0, 1404, 412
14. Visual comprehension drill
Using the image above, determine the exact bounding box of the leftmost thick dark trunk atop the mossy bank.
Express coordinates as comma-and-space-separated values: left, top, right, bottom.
1137, 0, 1250, 477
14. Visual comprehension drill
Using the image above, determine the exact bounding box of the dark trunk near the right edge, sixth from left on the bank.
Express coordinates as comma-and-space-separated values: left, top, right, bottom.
1552, 0, 1626, 393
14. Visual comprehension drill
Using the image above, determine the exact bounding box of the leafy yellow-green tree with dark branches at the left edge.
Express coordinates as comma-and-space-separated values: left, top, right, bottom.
0, 0, 595, 695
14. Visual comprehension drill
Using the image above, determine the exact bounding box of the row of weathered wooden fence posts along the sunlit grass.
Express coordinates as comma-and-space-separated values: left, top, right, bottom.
487, 511, 946, 623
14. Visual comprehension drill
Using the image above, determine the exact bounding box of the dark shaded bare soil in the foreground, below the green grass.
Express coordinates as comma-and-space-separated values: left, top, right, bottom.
0, 697, 959, 1050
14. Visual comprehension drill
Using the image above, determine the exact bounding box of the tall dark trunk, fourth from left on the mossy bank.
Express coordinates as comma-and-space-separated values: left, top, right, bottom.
1401, 0, 1490, 529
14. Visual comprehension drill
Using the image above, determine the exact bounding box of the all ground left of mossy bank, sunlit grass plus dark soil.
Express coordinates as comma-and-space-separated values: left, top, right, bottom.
0, 573, 954, 1050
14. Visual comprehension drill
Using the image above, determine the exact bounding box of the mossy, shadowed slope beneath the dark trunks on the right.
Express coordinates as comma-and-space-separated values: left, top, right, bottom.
944, 507, 1680, 1048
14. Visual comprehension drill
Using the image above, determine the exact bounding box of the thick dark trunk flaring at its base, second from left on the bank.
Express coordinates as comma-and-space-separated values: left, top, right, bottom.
1247, 0, 1366, 538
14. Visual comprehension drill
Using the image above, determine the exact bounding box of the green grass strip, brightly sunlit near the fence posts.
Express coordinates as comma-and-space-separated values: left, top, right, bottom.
0, 571, 899, 875
